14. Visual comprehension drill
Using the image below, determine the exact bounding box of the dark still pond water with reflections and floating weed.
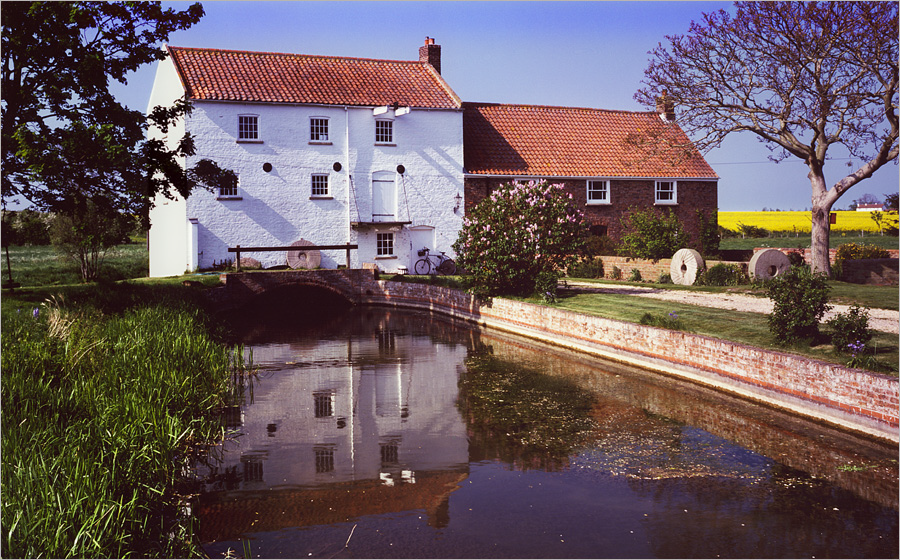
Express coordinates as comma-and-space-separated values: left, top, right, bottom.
194, 300, 898, 558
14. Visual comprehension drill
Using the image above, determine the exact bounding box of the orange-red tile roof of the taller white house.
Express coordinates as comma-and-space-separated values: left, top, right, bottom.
168, 46, 461, 109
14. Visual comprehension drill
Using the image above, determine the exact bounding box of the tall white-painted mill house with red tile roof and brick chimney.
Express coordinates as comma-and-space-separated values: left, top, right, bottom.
149, 39, 465, 276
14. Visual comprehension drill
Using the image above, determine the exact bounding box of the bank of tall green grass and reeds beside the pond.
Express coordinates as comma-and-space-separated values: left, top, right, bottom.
0, 282, 240, 558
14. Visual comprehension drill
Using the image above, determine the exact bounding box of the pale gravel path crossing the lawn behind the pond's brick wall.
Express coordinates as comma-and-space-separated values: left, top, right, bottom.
568, 282, 900, 334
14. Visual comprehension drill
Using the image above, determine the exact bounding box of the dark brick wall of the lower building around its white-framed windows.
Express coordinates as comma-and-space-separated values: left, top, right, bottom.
465, 177, 718, 248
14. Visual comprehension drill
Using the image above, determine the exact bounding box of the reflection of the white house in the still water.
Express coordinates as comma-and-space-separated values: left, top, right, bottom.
200, 320, 468, 540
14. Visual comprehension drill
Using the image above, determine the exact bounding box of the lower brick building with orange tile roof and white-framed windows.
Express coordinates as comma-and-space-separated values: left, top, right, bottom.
463, 102, 718, 248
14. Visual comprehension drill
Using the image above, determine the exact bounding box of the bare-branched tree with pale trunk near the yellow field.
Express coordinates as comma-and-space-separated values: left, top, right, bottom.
635, 2, 900, 274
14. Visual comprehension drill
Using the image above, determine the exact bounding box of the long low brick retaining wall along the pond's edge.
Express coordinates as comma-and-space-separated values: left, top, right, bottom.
363, 281, 900, 443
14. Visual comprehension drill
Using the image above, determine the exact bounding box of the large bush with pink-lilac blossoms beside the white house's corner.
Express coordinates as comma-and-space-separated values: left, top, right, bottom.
453, 181, 588, 301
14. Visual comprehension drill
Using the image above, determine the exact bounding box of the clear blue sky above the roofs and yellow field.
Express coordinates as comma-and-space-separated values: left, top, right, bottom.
114, 1, 900, 210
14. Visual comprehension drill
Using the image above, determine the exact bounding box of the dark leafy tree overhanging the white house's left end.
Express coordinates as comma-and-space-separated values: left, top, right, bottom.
0, 2, 235, 223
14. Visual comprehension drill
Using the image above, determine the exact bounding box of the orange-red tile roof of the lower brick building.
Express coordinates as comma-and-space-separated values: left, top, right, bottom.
463, 103, 717, 179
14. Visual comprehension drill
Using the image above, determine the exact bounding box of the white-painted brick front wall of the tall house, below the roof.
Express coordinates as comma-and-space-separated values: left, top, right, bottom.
180, 102, 463, 275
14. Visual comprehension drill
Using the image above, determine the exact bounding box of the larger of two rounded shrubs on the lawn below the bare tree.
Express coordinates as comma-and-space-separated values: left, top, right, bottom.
767, 266, 831, 344
